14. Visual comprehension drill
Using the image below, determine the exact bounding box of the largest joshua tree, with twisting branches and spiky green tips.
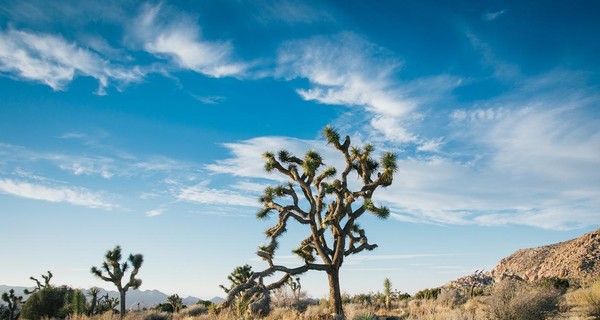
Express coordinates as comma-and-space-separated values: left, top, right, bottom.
223, 126, 396, 318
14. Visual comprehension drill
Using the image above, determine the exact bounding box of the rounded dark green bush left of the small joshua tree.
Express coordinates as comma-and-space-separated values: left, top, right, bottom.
21, 286, 73, 320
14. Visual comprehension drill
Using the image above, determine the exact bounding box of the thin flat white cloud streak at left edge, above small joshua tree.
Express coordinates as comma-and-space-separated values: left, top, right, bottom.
0, 179, 115, 210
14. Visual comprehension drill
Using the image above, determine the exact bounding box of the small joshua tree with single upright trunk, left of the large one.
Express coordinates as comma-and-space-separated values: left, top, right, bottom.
91, 246, 144, 318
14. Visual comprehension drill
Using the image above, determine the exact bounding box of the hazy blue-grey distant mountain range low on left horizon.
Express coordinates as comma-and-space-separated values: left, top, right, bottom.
0, 285, 224, 309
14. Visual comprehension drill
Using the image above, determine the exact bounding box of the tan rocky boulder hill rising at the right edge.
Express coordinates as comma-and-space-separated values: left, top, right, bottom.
489, 229, 600, 281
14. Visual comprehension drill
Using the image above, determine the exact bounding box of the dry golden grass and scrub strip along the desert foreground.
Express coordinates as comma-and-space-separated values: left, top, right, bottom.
62, 281, 600, 320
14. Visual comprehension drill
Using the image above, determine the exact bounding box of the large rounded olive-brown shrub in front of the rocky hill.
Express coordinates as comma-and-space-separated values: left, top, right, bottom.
488, 281, 561, 320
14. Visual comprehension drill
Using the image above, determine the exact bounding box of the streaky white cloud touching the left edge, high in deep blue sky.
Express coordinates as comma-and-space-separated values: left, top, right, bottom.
0, 29, 144, 95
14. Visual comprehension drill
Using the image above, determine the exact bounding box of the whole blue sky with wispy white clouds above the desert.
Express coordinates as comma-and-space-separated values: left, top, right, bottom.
0, 0, 600, 298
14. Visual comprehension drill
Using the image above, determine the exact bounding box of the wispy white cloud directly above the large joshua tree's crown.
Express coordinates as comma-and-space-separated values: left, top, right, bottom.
276, 32, 462, 150
